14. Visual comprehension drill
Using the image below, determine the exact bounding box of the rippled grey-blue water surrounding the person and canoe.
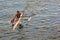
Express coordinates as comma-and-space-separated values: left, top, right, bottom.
0, 0, 60, 40
